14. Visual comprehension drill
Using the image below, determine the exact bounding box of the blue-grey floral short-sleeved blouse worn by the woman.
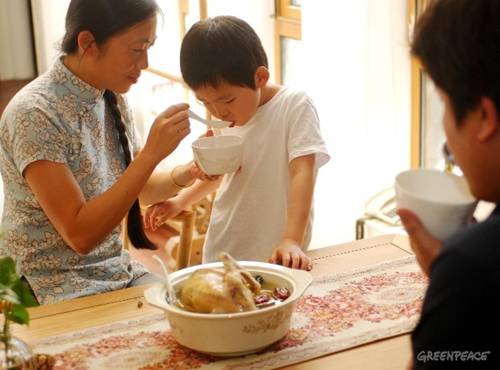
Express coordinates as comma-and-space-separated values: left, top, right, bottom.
0, 60, 147, 304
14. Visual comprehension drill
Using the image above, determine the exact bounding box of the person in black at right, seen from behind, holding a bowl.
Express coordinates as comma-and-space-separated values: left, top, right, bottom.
399, 0, 500, 369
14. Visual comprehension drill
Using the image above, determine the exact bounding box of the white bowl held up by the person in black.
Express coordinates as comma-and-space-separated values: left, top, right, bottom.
395, 169, 477, 240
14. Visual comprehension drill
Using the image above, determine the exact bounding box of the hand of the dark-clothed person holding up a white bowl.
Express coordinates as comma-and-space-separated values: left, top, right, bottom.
397, 209, 443, 275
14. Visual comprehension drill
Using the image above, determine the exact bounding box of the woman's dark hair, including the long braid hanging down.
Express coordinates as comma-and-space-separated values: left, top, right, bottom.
61, 0, 159, 249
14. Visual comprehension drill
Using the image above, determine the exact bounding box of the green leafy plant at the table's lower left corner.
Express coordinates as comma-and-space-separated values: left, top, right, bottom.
0, 257, 37, 368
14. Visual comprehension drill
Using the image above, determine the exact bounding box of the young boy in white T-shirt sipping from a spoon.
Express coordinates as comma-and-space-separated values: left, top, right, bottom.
145, 16, 329, 269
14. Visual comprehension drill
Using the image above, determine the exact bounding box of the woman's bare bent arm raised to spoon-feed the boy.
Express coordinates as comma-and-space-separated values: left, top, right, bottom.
23, 104, 189, 255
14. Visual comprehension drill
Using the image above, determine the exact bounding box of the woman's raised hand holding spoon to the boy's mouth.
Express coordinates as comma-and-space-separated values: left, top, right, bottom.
142, 103, 191, 163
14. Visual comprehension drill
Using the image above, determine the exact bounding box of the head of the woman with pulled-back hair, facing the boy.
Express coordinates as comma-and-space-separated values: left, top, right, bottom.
62, 0, 159, 93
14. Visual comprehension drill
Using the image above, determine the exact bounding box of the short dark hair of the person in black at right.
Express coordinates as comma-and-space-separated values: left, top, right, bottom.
412, 0, 500, 124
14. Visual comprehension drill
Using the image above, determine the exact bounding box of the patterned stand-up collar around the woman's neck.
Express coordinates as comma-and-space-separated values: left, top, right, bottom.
52, 57, 104, 109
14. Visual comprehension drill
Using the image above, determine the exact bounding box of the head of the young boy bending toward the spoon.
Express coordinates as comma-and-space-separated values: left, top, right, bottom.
180, 16, 269, 124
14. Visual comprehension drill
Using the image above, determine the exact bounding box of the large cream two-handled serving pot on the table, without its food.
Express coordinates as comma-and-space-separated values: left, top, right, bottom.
144, 261, 312, 356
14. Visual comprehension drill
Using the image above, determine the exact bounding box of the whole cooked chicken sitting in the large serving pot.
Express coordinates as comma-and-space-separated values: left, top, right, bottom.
179, 252, 261, 313
